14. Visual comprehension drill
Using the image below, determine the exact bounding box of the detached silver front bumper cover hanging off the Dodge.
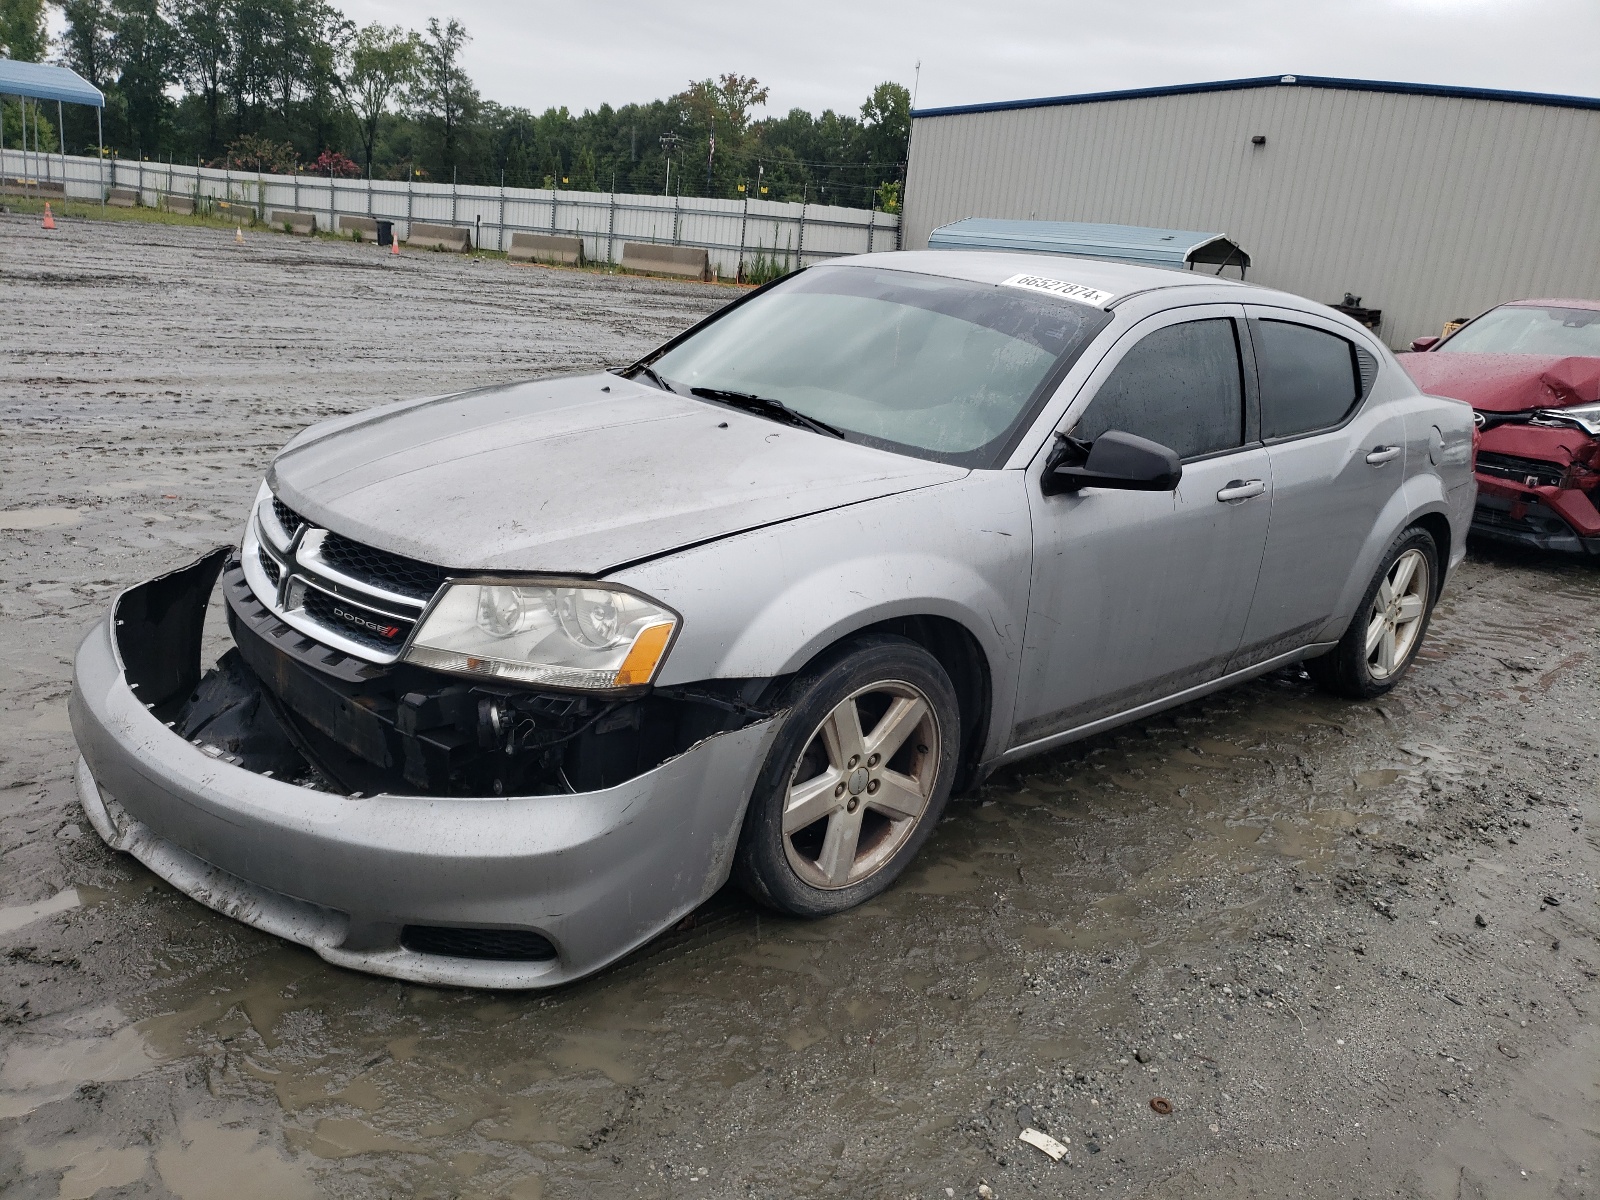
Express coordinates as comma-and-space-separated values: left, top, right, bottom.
70, 550, 776, 989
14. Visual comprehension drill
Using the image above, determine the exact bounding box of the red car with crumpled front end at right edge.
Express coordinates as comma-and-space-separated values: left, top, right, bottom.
1400, 299, 1600, 554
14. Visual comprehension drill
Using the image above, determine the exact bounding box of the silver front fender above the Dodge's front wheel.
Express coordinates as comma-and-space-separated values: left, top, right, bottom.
611, 470, 1032, 755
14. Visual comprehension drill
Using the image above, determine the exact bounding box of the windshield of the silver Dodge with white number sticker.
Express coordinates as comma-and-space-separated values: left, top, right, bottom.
651, 266, 1109, 467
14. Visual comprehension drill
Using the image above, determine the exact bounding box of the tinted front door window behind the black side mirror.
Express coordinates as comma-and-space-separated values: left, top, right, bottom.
1072, 317, 1245, 458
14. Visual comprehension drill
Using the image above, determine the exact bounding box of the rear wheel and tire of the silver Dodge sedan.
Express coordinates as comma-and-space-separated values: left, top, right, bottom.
1306, 525, 1440, 699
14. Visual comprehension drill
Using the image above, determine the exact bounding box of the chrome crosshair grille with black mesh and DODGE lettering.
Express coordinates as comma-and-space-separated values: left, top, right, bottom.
240, 490, 445, 662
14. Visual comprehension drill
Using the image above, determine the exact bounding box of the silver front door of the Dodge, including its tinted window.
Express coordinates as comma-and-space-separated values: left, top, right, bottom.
1013, 304, 1270, 746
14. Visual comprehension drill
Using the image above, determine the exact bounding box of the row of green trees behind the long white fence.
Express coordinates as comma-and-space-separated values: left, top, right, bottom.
53, 0, 910, 211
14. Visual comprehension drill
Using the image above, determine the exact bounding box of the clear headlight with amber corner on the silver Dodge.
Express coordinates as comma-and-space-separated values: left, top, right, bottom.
405, 584, 678, 691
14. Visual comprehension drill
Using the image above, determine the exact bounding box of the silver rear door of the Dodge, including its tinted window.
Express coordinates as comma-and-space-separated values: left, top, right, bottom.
1232, 306, 1405, 669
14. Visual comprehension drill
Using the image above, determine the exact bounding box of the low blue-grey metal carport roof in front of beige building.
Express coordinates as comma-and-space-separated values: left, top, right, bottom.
928, 216, 1250, 278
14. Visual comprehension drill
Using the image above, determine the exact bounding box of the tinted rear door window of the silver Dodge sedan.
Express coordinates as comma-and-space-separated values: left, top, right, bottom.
1250, 320, 1376, 438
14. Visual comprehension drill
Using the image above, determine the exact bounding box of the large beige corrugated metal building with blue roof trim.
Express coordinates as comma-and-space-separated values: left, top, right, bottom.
904, 75, 1600, 347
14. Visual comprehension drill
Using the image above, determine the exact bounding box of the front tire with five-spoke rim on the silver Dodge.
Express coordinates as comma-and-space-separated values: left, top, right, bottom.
734, 634, 962, 917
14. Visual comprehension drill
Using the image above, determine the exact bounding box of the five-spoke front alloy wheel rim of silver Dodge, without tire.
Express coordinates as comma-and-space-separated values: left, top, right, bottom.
782, 680, 941, 890
